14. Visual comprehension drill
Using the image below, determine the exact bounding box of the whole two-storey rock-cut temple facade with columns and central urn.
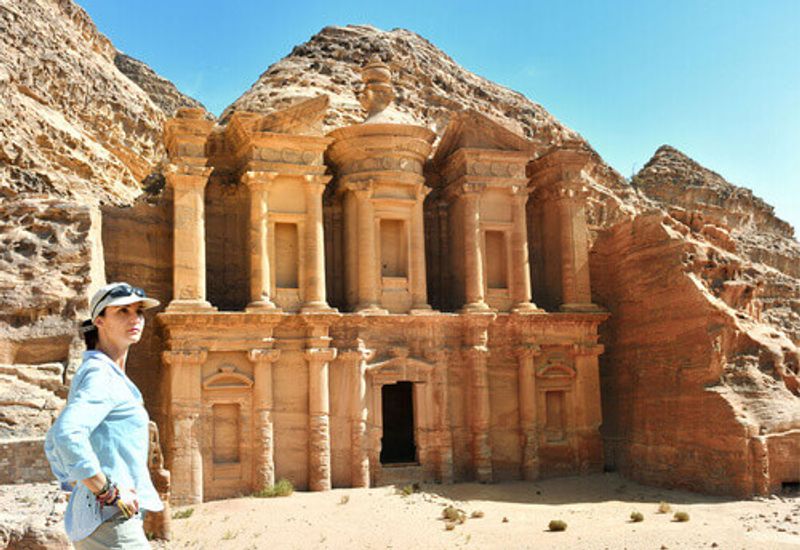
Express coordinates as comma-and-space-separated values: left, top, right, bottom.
155, 59, 607, 504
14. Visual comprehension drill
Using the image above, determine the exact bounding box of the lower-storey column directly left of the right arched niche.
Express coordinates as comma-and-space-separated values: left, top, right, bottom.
517, 345, 540, 481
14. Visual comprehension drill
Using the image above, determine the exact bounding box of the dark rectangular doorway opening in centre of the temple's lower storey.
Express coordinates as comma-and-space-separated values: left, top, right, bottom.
381, 382, 417, 464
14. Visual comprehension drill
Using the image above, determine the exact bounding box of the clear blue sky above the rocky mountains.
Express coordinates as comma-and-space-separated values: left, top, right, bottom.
78, 0, 800, 234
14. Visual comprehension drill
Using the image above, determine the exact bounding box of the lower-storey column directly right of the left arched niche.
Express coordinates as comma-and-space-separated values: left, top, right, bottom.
248, 349, 280, 491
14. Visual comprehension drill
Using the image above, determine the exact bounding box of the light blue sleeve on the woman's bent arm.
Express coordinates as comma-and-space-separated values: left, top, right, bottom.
45, 365, 114, 482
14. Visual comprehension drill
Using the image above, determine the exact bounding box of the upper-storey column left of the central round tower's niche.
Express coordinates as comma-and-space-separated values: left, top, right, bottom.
354, 187, 381, 312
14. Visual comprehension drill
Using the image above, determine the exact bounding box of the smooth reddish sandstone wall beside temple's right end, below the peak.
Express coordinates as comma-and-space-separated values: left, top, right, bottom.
592, 213, 800, 495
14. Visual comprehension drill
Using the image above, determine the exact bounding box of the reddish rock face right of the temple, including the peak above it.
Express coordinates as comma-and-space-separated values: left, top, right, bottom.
592, 146, 800, 494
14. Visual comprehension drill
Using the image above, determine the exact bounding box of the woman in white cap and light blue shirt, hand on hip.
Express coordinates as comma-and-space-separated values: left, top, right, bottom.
45, 283, 163, 550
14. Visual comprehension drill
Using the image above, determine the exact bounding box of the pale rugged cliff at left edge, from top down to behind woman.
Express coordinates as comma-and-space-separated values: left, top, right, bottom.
0, 0, 206, 374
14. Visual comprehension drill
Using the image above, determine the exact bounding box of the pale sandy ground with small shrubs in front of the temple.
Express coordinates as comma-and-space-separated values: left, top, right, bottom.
162, 474, 800, 550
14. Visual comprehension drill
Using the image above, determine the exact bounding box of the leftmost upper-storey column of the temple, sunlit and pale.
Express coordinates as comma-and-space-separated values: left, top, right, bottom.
166, 167, 212, 311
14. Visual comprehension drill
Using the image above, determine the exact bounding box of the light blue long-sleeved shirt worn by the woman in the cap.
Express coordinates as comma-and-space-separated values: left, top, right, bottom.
44, 351, 164, 541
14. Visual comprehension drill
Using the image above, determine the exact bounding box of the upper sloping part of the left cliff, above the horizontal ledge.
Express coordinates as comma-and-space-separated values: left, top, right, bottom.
0, 0, 169, 202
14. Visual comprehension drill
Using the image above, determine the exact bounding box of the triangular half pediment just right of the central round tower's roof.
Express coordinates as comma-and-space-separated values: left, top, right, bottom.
433, 109, 533, 164
